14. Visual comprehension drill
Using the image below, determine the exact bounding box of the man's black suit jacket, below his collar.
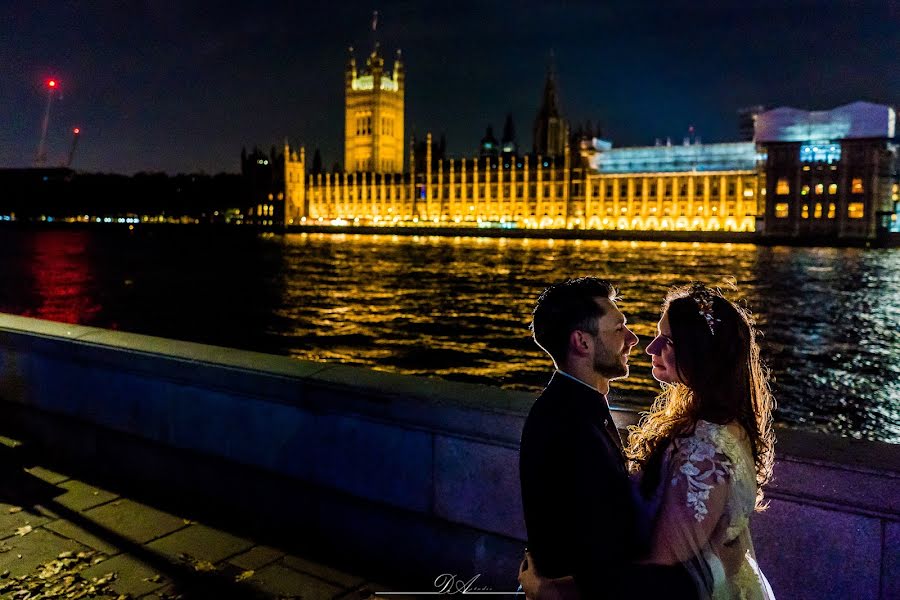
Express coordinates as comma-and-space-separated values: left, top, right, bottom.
519, 373, 636, 598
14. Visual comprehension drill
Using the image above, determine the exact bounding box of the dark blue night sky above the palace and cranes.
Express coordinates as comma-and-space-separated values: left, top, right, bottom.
0, 0, 900, 174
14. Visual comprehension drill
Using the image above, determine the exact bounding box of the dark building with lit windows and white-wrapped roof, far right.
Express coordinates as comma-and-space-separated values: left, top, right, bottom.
756, 102, 898, 239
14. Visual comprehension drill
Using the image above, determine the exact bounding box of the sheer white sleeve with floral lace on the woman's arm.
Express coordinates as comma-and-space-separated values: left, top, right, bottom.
650, 426, 734, 564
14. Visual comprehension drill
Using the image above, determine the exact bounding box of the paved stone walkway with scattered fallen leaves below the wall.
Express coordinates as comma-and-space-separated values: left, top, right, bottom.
0, 438, 391, 600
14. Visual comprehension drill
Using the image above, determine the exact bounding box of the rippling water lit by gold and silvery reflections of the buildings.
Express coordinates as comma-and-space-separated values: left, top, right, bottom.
278, 234, 900, 441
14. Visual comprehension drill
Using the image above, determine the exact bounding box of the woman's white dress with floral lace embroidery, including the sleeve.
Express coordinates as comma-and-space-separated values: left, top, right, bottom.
647, 421, 774, 600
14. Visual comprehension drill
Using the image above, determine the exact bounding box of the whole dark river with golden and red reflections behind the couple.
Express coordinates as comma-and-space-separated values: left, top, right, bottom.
0, 226, 900, 443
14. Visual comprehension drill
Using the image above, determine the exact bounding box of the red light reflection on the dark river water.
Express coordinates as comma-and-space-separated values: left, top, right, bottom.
25, 231, 101, 324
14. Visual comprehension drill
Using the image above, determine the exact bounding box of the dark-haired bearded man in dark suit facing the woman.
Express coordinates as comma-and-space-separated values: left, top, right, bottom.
519, 277, 694, 600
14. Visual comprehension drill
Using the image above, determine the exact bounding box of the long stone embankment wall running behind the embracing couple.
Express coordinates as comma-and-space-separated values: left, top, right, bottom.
0, 315, 900, 599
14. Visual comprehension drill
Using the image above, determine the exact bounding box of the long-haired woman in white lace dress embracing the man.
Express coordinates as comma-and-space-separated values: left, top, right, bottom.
520, 284, 774, 600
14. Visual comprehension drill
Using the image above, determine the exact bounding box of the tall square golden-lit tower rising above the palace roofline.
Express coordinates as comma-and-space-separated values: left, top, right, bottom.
344, 42, 406, 173
